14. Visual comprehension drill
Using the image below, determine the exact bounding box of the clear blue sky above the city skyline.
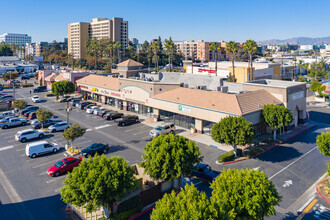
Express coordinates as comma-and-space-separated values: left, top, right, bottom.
0, 0, 330, 43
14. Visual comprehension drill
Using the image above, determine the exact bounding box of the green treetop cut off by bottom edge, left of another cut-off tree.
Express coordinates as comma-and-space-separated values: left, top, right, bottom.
150, 184, 220, 220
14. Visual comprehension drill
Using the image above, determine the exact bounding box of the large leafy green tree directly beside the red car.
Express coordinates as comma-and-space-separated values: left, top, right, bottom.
60, 154, 134, 212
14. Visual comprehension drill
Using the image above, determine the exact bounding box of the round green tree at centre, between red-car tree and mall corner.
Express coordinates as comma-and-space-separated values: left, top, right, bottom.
141, 134, 202, 187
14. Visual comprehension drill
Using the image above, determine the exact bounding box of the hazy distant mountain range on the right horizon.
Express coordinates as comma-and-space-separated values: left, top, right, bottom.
258, 36, 330, 45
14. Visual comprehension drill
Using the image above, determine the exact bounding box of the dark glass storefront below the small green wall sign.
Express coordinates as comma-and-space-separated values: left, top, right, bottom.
159, 110, 195, 129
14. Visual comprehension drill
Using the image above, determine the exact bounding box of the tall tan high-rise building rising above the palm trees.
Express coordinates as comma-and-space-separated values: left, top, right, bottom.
68, 18, 128, 59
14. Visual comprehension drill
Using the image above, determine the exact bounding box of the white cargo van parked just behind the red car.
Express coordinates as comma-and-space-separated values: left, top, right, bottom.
25, 141, 60, 158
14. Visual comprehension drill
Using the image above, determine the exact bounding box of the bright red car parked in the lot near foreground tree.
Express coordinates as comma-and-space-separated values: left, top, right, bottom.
47, 157, 82, 176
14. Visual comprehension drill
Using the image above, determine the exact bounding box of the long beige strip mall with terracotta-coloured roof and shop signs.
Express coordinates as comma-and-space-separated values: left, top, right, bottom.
77, 75, 306, 134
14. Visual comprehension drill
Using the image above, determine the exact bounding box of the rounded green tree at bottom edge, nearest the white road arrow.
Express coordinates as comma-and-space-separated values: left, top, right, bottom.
210, 169, 282, 219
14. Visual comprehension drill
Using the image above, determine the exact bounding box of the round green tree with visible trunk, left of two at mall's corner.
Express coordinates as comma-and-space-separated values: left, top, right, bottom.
211, 116, 255, 156
